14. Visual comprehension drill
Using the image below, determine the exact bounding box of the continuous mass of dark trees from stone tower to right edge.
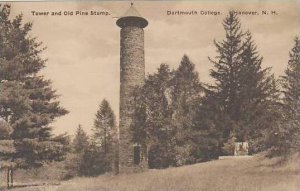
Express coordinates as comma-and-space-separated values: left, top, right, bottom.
132, 12, 300, 168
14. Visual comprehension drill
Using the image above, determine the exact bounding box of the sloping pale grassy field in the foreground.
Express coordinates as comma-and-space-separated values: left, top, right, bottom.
2, 156, 300, 191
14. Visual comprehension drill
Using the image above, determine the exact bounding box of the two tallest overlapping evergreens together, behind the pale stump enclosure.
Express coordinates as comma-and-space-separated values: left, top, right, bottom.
207, 12, 279, 152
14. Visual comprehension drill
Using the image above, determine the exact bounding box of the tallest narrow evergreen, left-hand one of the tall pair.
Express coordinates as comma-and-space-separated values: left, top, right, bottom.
207, 12, 245, 140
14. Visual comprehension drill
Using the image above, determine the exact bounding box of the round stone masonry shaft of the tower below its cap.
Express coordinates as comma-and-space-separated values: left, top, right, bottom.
119, 26, 145, 173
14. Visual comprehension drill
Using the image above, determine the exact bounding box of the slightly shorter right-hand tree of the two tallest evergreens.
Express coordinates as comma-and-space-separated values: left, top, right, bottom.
235, 32, 279, 146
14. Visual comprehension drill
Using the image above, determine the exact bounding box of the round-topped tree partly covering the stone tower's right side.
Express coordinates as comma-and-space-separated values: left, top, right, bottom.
132, 64, 175, 168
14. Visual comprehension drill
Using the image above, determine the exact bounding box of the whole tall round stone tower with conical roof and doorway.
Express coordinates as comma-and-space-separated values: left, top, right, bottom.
116, 3, 148, 173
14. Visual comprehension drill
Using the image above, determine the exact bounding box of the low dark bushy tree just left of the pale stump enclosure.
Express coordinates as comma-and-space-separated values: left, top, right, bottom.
191, 96, 226, 162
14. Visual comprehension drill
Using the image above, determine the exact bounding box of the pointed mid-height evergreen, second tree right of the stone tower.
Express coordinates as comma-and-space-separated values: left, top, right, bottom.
171, 55, 202, 165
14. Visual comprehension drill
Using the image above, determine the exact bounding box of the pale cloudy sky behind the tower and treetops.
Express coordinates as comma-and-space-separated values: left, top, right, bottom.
11, 0, 300, 135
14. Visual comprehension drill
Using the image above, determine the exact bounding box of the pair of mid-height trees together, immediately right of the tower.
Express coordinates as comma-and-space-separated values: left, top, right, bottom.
133, 58, 201, 168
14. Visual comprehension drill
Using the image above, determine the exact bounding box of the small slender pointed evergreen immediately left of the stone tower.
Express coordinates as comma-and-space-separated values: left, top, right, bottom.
93, 99, 117, 171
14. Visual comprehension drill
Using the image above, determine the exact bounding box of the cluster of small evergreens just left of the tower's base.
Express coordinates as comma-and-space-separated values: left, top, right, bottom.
64, 99, 118, 179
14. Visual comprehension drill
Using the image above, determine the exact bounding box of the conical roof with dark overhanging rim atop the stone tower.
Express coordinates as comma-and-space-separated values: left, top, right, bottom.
117, 3, 148, 28
